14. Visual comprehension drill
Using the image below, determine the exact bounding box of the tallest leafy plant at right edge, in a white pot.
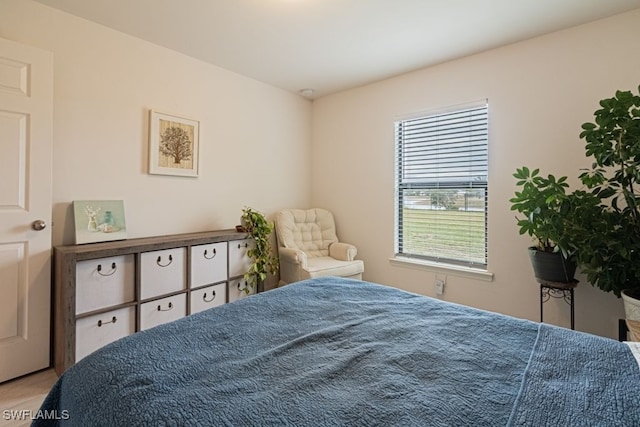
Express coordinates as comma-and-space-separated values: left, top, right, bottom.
575, 87, 640, 320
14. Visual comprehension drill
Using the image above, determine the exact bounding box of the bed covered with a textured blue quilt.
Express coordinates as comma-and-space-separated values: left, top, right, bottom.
34, 277, 640, 426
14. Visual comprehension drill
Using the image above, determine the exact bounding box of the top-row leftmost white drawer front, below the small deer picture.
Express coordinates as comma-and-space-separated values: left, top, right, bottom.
76, 255, 135, 314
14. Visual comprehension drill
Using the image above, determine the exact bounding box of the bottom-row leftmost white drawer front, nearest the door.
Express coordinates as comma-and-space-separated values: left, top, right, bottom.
76, 307, 136, 362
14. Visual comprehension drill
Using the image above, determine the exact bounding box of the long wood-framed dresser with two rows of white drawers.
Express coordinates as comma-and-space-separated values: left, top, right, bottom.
53, 230, 260, 374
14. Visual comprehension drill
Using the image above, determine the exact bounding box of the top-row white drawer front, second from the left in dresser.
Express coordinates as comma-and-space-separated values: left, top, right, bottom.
140, 248, 187, 300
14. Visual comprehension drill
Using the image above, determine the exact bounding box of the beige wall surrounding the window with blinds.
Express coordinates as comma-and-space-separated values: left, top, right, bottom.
312, 10, 640, 337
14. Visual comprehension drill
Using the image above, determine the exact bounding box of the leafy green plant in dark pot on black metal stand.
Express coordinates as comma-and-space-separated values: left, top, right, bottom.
509, 166, 576, 282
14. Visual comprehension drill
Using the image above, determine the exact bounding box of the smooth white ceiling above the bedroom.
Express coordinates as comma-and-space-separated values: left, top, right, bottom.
36, 0, 640, 98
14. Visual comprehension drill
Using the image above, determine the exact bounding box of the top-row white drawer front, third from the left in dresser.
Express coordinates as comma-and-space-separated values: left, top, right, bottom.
190, 242, 227, 288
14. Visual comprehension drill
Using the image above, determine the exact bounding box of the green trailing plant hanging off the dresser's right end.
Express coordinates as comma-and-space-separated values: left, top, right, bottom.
242, 207, 278, 293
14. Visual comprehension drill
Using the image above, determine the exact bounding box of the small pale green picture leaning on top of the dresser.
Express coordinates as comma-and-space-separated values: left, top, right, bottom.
73, 200, 127, 245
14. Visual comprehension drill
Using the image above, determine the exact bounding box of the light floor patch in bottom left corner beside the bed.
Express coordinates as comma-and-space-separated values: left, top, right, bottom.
0, 369, 58, 427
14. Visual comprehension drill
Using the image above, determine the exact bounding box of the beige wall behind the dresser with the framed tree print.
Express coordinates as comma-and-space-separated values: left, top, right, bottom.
0, 0, 311, 252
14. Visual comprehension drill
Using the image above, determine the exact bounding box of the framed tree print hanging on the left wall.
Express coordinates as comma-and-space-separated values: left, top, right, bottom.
149, 110, 200, 177
